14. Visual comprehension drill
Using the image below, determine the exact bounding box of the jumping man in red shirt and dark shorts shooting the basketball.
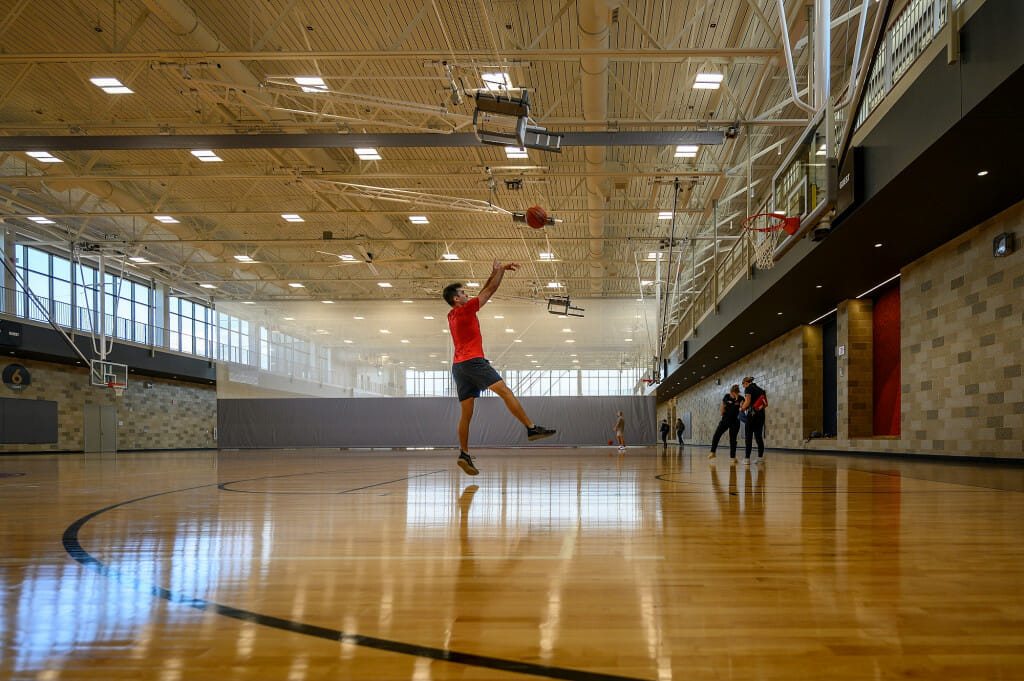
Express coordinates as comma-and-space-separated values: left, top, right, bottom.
441, 260, 555, 475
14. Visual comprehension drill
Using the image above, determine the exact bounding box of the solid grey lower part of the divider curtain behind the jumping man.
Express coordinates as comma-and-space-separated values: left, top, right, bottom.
217, 395, 657, 449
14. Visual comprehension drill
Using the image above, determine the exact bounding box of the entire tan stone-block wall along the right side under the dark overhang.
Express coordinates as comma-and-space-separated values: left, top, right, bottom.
676, 197, 1024, 460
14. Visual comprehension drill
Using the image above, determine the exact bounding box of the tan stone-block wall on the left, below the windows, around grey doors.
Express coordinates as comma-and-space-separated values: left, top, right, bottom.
0, 358, 217, 452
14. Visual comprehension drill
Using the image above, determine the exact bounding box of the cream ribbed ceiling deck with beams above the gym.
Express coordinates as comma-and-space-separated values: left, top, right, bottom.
0, 0, 880, 372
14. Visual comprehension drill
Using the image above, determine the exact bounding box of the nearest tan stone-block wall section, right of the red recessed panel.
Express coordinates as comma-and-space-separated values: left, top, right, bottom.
900, 202, 1024, 458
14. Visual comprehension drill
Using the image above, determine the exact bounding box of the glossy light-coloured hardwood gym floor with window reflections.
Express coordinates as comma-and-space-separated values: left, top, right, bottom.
0, 446, 1024, 681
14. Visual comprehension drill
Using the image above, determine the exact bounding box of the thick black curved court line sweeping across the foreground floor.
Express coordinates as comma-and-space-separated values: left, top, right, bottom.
61, 476, 646, 681
